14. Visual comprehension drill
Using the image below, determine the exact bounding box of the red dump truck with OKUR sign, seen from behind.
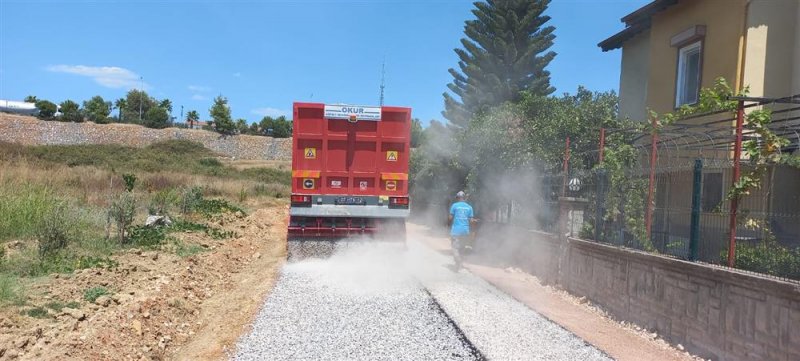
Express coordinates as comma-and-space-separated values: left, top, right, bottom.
288, 103, 411, 258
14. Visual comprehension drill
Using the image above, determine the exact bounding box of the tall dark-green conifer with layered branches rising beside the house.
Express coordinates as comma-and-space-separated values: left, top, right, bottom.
442, 0, 556, 126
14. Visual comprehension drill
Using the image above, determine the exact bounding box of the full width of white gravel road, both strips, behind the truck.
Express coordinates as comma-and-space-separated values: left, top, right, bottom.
232, 238, 610, 360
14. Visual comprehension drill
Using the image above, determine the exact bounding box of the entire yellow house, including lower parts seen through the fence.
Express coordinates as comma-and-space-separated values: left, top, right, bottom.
598, 0, 800, 260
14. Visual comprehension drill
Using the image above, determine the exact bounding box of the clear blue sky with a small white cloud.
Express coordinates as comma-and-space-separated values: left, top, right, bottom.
0, 0, 649, 122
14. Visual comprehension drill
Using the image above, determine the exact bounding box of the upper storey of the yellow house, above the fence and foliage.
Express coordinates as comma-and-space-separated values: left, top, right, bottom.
598, 0, 800, 120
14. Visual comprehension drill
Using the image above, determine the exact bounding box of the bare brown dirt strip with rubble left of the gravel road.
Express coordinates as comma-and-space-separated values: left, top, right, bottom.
0, 206, 287, 360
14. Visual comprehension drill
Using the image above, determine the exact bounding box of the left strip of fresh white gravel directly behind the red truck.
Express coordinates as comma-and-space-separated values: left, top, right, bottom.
234, 245, 479, 360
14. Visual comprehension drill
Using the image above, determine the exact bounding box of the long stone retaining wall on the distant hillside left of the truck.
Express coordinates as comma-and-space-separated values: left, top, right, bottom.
0, 114, 292, 160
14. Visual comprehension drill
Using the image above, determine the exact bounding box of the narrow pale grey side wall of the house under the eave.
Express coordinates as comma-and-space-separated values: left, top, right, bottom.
619, 31, 650, 121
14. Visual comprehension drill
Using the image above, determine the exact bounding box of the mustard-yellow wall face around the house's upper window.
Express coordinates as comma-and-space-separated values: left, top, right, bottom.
647, 0, 746, 113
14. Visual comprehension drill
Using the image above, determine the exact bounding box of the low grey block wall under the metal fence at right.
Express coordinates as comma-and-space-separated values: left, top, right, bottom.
482, 226, 800, 361
